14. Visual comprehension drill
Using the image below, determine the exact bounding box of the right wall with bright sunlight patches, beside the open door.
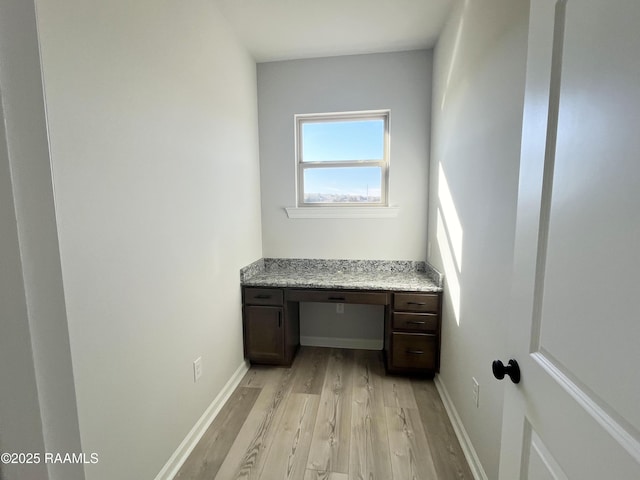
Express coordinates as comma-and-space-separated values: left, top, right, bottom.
429, 0, 528, 478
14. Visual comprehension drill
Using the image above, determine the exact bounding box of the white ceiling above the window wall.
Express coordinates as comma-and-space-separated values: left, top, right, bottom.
213, 0, 452, 63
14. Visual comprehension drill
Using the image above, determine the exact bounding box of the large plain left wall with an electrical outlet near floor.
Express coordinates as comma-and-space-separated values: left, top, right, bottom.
37, 0, 262, 480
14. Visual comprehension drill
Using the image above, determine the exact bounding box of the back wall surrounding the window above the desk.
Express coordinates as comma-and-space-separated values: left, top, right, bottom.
258, 50, 432, 260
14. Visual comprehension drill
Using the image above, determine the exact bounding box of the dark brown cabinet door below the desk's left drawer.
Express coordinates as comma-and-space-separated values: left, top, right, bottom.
244, 306, 284, 363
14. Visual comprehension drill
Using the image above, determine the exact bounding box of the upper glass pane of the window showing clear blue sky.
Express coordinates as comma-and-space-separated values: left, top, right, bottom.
301, 118, 384, 162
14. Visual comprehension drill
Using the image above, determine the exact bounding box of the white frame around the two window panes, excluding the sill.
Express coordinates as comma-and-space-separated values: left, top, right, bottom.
294, 110, 390, 209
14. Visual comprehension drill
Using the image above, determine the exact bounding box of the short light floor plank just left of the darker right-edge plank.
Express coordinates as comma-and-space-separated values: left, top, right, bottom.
386, 407, 438, 480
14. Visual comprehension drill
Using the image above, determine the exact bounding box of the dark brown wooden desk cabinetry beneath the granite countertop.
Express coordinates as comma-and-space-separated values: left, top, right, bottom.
242, 287, 442, 375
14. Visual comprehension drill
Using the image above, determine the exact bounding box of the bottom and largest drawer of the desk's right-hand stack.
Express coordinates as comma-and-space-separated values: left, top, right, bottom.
391, 333, 437, 370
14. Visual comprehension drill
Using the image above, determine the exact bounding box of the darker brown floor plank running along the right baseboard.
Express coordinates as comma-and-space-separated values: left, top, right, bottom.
411, 380, 473, 480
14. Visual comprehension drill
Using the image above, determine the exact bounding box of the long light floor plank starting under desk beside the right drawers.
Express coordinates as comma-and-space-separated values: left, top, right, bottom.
349, 351, 392, 480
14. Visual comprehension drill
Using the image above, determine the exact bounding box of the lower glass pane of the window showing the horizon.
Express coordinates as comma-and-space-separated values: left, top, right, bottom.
304, 167, 382, 203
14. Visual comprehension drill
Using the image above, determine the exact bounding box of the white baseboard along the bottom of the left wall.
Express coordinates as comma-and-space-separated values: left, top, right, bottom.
155, 362, 249, 480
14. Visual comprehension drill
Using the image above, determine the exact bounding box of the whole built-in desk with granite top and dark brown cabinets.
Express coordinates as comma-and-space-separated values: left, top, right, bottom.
240, 259, 442, 375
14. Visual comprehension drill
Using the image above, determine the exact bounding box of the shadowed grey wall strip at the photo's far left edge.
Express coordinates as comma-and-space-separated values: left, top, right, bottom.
0, 0, 84, 480
